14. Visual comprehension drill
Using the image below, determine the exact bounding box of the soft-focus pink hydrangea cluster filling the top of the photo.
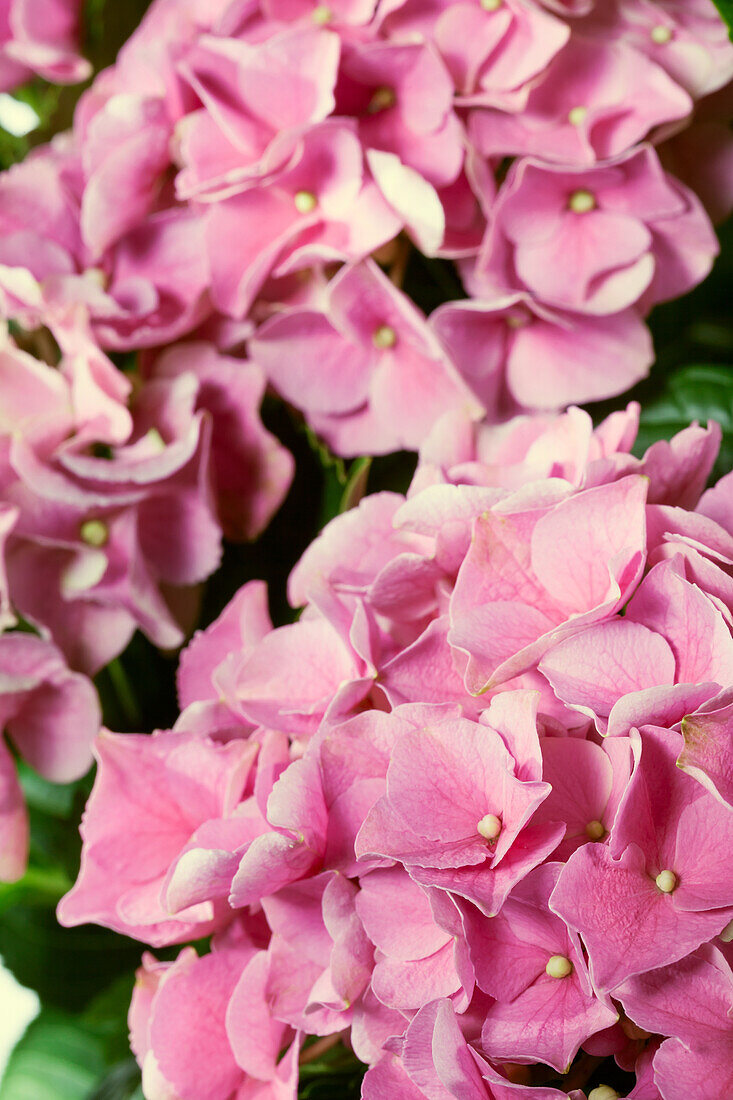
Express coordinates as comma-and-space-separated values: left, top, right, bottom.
0, 0, 733, 455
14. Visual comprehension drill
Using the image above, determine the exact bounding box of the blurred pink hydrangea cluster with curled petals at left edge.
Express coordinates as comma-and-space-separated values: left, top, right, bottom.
0, 321, 293, 880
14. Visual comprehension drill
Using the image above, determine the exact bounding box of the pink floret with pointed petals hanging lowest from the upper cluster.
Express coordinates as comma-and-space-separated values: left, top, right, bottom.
250, 262, 480, 455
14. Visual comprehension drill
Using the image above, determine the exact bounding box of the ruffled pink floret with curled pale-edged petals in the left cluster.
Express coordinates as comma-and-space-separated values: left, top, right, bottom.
6, 367, 221, 670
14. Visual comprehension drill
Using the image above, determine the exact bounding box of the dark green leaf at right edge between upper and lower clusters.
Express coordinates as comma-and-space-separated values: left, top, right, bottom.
634, 363, 733, 479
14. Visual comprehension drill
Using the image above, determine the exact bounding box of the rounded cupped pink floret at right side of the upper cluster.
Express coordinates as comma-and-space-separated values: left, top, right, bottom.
480, 146, 718, 314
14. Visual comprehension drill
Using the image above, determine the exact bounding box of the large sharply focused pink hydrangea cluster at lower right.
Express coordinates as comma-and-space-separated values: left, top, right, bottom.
59, 406, 733, 1100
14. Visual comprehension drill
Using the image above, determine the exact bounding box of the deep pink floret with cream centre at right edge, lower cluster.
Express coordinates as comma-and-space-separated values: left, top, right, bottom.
550, 726, 733, 989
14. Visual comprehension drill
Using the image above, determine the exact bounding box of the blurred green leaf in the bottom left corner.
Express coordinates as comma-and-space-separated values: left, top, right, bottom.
0, 1009, 106, 1100
